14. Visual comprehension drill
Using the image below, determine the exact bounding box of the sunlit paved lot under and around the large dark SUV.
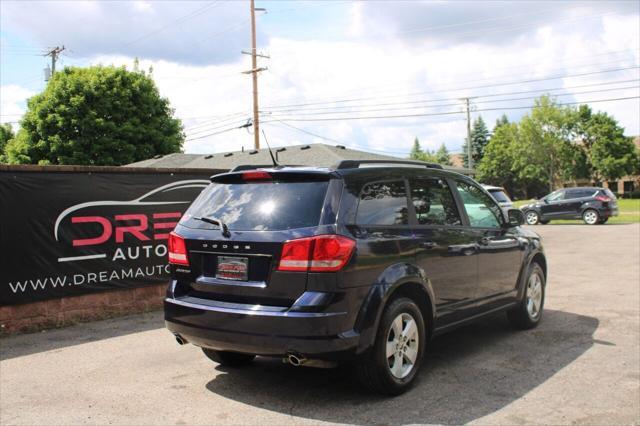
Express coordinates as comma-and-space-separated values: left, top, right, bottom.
0, 224, 640, 425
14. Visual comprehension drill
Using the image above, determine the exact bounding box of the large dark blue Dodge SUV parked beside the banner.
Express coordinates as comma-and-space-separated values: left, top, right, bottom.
165, 161, 547, 394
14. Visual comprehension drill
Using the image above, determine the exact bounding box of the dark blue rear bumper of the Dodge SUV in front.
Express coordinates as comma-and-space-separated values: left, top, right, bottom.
164, 297, 360, 361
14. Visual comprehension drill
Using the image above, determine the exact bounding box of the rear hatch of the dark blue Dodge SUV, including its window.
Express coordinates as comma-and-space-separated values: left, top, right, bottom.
174, 169, 341, 309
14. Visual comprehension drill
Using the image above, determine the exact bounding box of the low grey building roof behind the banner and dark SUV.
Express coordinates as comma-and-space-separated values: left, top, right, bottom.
124, 143, 472, 174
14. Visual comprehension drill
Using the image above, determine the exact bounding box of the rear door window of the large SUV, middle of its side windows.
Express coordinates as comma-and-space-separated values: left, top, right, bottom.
410, 178, 462, 226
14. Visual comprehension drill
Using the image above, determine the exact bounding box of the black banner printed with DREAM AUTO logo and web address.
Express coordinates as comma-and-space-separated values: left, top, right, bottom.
0, 170, 214, 305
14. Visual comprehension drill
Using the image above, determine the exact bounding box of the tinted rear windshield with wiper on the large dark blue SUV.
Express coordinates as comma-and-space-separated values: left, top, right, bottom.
180, 181, 329, 231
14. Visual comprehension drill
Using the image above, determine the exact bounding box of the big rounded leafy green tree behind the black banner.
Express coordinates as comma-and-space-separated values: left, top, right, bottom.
7, 66, 184, 166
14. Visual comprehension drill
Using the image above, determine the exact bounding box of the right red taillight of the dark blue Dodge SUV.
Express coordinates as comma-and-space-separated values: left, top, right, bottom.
278, 235, 356, 272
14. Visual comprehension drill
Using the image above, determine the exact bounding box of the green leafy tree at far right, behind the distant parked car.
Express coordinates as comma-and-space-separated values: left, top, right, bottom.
571, 105, 639, 181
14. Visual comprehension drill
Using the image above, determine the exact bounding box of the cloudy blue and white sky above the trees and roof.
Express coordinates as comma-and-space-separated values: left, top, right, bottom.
0, 0, 640, 156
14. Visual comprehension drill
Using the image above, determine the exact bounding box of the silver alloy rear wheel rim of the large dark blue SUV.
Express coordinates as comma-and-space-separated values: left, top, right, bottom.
386, 312, 420, 379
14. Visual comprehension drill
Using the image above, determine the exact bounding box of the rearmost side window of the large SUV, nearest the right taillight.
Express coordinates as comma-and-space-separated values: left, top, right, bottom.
356, 180, 409, 225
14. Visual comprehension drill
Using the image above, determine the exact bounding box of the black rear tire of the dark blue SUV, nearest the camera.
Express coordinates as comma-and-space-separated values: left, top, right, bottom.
356, 297, 426, 395
